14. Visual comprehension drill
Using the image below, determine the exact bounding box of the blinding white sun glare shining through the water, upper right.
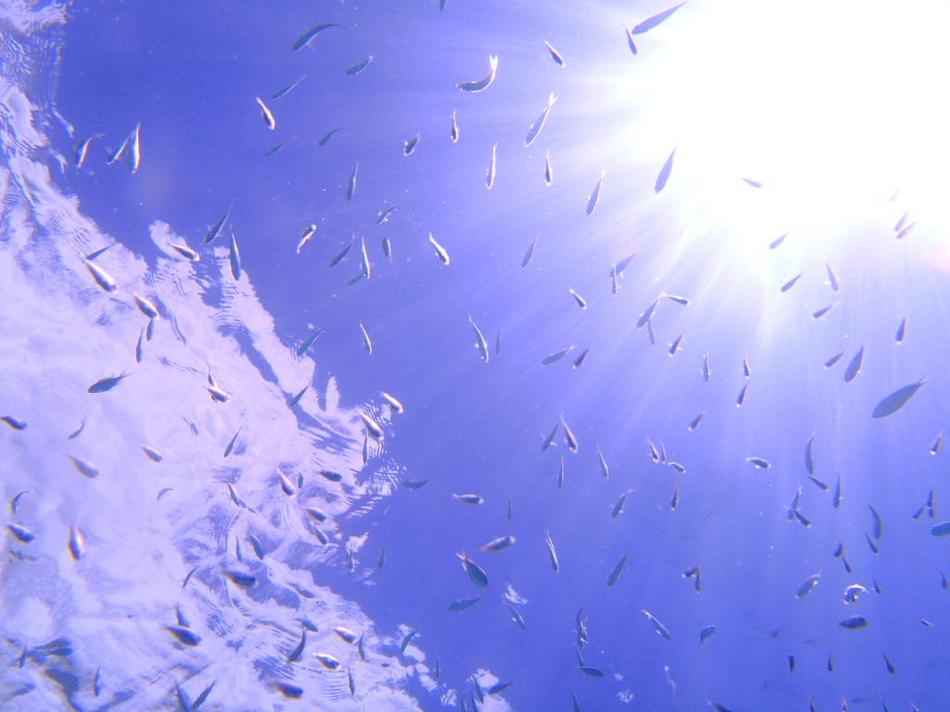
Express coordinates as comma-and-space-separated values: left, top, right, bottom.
622, 0, 950, 242
